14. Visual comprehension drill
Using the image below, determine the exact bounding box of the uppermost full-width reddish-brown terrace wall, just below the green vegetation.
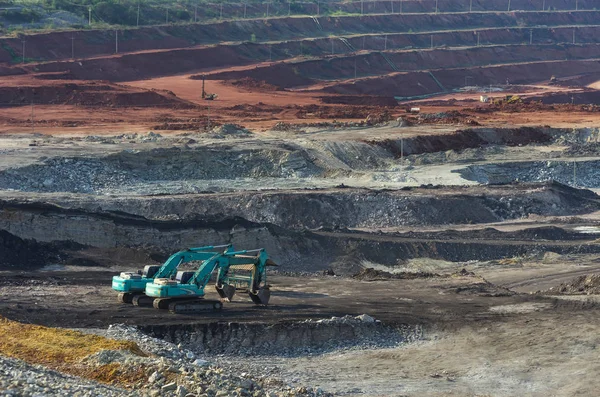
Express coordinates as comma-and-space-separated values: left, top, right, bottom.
0, 10, 600, 67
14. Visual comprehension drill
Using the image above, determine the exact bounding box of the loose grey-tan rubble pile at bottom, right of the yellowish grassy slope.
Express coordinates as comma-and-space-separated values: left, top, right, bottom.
76, 324, 338, 397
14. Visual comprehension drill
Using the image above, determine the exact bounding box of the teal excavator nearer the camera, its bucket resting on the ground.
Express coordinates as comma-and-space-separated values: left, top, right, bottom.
146, 248, 276, 313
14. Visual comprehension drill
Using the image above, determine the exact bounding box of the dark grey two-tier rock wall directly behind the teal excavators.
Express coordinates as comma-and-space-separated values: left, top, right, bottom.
0, 185, 600, 274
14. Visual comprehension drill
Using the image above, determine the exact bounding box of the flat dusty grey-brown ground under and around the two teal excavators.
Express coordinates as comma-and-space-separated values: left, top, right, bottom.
0, 252, 600, 396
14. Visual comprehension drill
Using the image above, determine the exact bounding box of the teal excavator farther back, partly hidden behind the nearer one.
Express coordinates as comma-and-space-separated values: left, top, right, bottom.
112, 244, 233, 306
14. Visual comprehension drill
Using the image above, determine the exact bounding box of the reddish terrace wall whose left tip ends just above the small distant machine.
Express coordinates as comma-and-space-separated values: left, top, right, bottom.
210, 43, 600, 90
